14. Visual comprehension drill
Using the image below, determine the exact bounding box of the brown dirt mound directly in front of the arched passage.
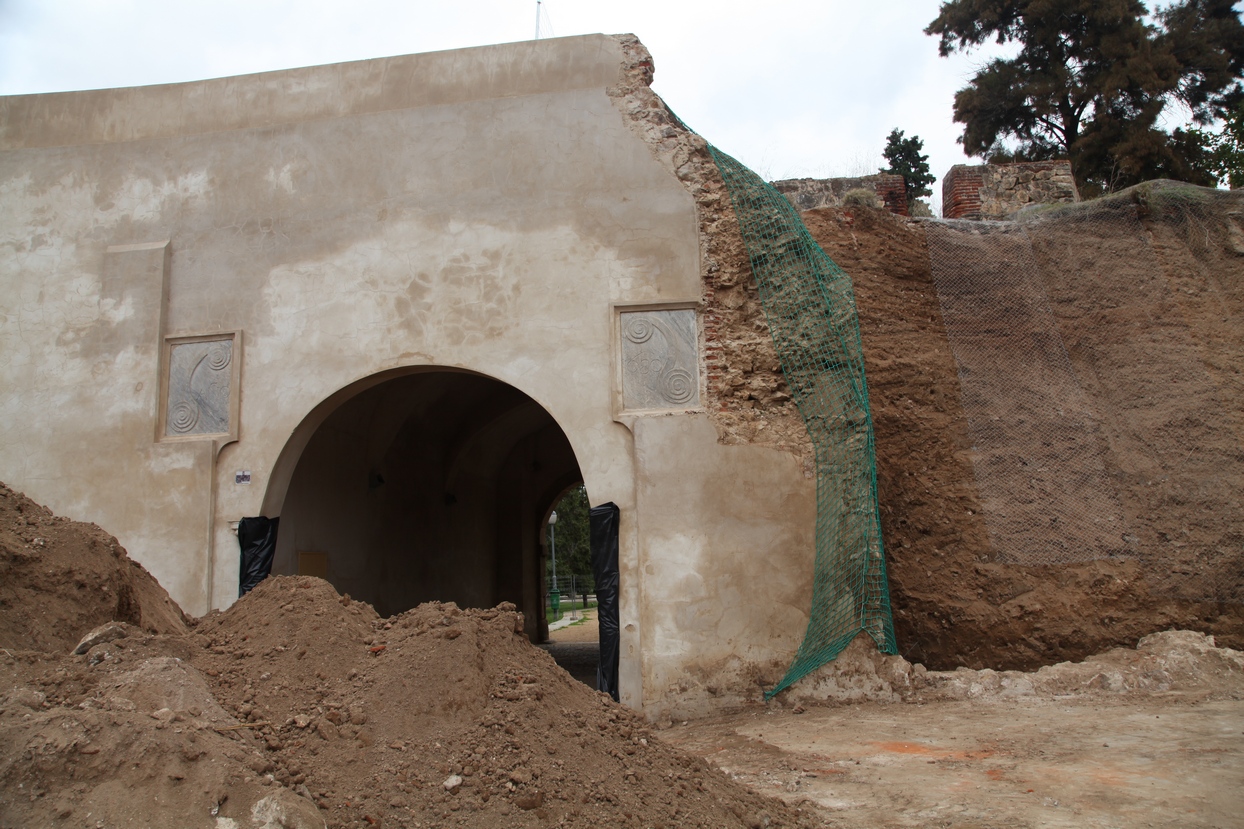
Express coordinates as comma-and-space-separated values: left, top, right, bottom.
194, 578, 811, 827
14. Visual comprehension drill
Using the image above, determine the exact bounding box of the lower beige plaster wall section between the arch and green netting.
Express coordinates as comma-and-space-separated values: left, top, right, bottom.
634, 415, 816, 716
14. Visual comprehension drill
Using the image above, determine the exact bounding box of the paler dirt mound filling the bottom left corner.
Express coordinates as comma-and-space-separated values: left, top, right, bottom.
0, 637, 298, 829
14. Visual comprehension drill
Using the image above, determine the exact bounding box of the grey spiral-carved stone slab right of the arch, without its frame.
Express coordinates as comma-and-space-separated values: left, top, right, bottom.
620, 309, 699, 410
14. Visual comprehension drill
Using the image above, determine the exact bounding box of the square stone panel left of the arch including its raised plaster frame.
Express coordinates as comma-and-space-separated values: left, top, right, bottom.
156, 330, 243, 443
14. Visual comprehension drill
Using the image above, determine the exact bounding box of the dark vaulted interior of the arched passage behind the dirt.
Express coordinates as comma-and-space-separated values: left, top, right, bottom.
272, 370, 582, 641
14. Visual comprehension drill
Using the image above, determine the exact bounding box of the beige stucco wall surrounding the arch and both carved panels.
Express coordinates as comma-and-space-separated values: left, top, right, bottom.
0, 35, 812, 708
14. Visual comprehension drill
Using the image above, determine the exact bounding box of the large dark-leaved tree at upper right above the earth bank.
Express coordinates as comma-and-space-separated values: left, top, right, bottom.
924, 0, 1244, 194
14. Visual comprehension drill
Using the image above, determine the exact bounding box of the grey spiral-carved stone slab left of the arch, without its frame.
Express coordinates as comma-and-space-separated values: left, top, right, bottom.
164, 337, 234, 437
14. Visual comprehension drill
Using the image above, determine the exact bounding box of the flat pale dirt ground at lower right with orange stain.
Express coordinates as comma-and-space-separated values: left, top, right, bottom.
662, 695, 1244, 829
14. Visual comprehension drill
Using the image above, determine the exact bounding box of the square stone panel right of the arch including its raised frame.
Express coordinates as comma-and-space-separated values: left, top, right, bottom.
613, 300, 707, 417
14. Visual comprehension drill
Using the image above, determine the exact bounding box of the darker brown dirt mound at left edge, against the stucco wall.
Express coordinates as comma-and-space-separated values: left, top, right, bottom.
0, 484, 187, 651
